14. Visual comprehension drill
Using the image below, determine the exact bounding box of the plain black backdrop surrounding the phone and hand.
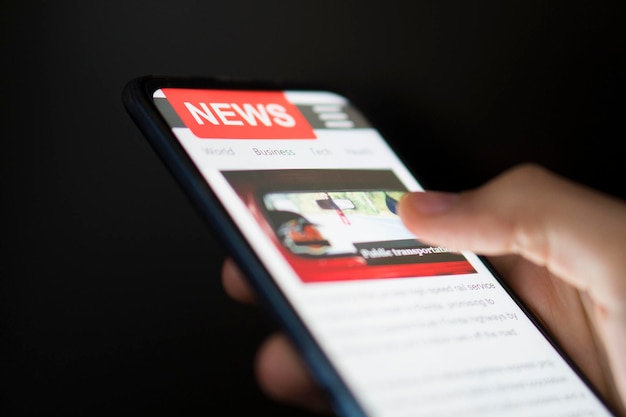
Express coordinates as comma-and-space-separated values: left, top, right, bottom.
0, 0, 626, 417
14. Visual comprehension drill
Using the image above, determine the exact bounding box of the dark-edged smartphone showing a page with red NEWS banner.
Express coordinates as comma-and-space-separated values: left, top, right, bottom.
123, 76, 614, 417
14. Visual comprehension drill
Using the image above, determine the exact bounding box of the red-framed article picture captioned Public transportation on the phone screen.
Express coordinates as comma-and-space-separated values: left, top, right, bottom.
222, 169, 476, 282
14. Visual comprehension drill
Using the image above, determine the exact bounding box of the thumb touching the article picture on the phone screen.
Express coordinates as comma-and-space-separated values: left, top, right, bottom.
398, 164, 626, 309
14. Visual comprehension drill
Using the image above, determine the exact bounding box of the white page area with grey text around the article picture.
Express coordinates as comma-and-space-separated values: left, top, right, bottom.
155, 92, 610, 417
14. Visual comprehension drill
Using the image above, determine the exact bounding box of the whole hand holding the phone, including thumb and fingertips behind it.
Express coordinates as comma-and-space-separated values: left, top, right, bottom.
222, 165, 626, 415
